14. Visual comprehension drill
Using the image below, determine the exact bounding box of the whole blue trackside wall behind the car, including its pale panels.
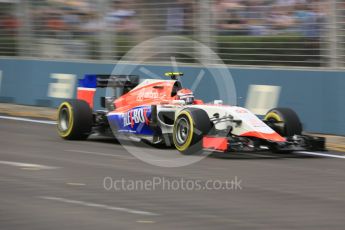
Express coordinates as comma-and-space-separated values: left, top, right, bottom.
0, 58, 345, 135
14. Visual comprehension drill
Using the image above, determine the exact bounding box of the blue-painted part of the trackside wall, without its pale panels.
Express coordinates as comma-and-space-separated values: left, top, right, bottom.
0, 59, 345, 135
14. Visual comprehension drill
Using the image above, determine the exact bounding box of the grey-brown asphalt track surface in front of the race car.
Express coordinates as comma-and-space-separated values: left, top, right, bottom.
0, 119, 345, 230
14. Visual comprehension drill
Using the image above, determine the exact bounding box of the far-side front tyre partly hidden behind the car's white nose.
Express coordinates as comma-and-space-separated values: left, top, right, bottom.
264, 108, 302, 137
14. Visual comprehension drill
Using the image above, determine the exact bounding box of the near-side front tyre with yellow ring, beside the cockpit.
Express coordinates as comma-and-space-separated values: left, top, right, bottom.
173, 108, 213, 155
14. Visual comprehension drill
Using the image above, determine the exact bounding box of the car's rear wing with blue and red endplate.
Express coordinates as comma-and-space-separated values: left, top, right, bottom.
77, 74, 139, 108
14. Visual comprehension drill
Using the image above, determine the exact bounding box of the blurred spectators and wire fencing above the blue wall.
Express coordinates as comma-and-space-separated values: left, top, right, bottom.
0, 0, 345, 68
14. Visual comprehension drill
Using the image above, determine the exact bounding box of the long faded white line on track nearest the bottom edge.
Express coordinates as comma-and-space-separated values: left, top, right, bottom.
39, 196, 159, 216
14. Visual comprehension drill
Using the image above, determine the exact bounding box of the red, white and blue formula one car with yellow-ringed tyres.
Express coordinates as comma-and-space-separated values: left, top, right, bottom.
57, 73, 325, 154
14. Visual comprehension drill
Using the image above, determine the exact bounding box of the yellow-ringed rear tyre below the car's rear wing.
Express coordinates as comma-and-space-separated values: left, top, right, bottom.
57, 100, 93, 140
